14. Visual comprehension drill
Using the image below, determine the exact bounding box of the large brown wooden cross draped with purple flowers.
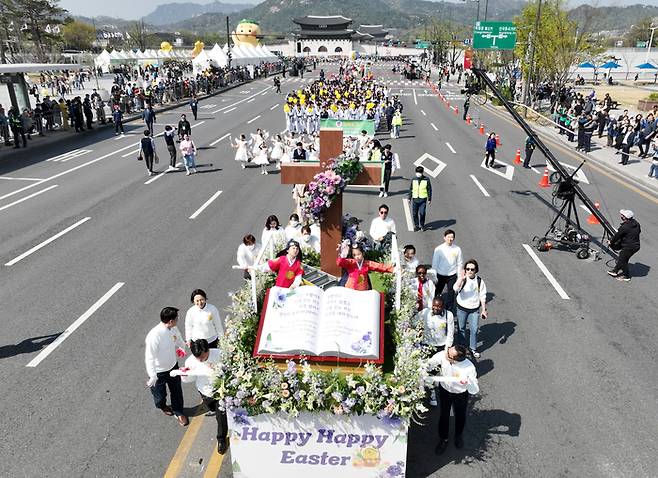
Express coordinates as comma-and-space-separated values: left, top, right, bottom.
281, 128, 382, 277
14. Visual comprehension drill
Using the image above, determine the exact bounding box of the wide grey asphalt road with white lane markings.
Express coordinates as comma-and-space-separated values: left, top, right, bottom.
0, 67, 658, 477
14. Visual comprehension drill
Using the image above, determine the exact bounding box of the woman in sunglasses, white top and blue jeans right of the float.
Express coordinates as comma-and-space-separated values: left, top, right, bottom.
454, 259, 487, 358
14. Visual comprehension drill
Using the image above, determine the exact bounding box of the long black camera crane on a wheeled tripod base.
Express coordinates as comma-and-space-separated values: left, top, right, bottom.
464, 67, 617, 259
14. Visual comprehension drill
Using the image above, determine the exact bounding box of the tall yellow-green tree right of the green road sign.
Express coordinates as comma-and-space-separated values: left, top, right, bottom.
514, 0, 602, 105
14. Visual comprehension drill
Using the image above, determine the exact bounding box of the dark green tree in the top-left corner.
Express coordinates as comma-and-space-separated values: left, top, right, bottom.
0, 0, 66, 62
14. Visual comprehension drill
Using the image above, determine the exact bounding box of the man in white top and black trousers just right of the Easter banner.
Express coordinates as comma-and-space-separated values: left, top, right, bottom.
427, 345, 480, 455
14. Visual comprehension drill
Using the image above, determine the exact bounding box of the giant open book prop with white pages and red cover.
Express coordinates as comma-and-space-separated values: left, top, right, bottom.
254, 286, 384, 363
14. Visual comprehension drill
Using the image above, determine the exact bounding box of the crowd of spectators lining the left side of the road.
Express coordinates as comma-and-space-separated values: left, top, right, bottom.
0, 61, 280, 148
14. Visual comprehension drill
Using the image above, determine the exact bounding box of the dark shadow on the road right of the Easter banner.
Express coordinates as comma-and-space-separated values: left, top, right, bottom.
406, 397, 521, 478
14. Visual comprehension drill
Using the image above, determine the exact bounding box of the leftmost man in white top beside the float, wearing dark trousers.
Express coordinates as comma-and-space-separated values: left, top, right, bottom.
144, 307, 189, 426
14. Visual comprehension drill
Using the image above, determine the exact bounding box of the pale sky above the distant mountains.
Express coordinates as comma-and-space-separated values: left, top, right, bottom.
59, 0, 656, 20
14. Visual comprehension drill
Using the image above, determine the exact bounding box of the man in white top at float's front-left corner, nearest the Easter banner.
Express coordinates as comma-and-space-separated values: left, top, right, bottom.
171, 339, 228, 455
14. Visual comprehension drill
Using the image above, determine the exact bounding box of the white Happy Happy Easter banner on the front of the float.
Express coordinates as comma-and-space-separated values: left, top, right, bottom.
227, 412, 407, 478
